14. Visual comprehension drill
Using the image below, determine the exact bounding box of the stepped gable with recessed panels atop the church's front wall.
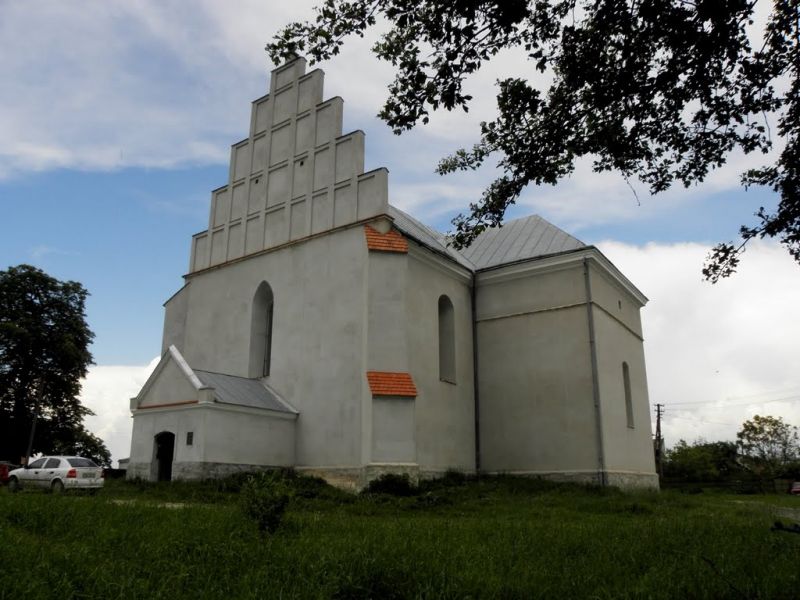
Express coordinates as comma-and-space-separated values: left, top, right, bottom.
189, 58, 388, 272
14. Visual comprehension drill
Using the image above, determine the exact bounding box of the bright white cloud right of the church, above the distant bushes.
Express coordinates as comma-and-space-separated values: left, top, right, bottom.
598, 241, 800, 445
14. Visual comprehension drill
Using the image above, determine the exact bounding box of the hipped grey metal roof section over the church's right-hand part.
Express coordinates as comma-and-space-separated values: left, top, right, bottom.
461, 215, 586, 270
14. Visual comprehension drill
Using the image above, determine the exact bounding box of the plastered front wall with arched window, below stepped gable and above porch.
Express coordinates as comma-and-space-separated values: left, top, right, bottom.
170, 226, 367, 466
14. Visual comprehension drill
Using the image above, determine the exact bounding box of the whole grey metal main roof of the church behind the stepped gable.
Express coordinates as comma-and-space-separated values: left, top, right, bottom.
389, 205, 586, 271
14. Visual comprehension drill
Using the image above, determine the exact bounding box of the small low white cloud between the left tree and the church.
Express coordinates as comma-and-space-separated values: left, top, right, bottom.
80, 357, 159, 464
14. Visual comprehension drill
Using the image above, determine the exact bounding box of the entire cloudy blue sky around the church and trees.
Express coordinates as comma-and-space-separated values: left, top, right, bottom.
0, 0, 800, 468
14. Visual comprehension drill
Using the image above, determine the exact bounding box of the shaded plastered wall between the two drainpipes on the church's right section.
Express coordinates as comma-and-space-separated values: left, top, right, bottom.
477, 264, 598, 473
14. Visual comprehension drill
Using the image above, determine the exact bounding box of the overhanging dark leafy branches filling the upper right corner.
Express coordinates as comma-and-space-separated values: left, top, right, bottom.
267, 0, 800, 282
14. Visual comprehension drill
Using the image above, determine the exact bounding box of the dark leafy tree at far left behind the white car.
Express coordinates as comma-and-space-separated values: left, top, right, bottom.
0, 265, 111, 465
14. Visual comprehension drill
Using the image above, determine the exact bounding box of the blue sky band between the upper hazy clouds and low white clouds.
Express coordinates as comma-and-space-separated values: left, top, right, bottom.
0, 155, 775, 364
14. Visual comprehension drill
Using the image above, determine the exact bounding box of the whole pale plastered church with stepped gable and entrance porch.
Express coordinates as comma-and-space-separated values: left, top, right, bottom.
128, 58, 658, 489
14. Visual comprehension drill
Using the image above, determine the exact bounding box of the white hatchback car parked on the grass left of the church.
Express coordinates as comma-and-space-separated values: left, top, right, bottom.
8, 456, 104, 494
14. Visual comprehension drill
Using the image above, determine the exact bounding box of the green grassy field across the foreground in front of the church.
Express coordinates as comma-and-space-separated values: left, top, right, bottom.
0, 477, 800, 600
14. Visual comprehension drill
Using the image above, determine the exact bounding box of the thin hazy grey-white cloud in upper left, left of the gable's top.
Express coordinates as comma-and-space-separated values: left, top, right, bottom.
0, 0, 294, 177
